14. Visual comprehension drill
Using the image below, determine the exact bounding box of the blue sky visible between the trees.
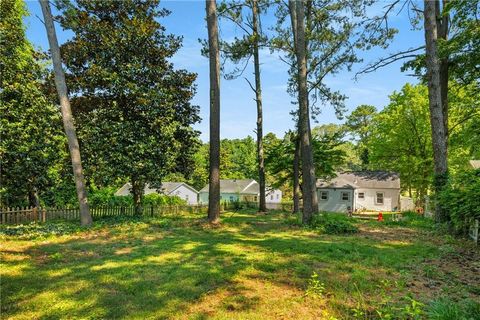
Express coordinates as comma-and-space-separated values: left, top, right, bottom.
25, 1, 424, 141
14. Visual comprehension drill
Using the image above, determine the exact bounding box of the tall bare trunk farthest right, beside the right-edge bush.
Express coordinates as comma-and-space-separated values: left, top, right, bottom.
424, 0, 448, 222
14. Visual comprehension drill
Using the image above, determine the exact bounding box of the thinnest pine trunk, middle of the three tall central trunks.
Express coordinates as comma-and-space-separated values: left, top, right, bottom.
251, 0, 267, 212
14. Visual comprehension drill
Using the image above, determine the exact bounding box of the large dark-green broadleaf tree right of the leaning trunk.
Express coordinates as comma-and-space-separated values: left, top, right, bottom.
58, 0, 199, 213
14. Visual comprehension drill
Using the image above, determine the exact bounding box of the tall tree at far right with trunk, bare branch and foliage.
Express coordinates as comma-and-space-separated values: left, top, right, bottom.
360, 0, 480, 221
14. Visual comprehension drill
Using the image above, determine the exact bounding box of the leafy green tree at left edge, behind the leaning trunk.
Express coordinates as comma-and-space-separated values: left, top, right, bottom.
0, 0, 66, 206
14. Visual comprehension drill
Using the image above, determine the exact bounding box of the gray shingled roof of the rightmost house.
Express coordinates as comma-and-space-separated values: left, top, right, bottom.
317, 171, 400, 189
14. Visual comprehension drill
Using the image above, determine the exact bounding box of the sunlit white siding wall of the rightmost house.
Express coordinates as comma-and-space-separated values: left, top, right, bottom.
354, 188, 400, 211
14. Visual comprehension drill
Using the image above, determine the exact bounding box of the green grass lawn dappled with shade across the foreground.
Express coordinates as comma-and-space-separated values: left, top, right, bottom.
0, 211, 480, 319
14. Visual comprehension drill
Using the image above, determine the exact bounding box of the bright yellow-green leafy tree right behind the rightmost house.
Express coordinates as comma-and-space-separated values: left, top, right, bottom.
367, 84, 433, 202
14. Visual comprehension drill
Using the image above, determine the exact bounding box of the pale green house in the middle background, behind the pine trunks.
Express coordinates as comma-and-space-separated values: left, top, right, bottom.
199, 179, 282, 204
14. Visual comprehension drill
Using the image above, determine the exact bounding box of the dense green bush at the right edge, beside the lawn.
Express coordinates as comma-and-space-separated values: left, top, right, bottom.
438, 169, 480, 232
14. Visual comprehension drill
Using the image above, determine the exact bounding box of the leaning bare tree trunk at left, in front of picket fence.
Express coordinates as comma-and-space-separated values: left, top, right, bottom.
40, 0, 92, 226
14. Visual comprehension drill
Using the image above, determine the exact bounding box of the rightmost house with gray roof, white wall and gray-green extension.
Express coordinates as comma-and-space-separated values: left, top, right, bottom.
317, 171, 400, 212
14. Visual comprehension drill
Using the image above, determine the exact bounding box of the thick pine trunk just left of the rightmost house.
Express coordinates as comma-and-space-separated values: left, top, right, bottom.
289, 0, 318, 223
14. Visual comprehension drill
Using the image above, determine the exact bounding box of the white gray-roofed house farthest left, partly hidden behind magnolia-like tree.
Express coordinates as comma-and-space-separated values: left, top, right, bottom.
115, 182, 198, 204
